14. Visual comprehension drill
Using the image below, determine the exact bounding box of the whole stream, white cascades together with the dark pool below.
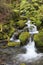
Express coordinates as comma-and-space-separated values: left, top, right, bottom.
0, 20, 43, 65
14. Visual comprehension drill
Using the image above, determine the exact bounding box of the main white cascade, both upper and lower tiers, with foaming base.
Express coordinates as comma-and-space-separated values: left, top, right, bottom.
17, 20, 41, 61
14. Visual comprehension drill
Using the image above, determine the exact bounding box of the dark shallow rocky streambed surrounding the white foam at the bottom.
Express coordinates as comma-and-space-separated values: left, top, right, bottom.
0, 47, 43, 65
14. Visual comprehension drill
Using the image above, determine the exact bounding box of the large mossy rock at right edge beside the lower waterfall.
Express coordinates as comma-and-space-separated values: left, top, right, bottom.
34, 31, 43, 47
